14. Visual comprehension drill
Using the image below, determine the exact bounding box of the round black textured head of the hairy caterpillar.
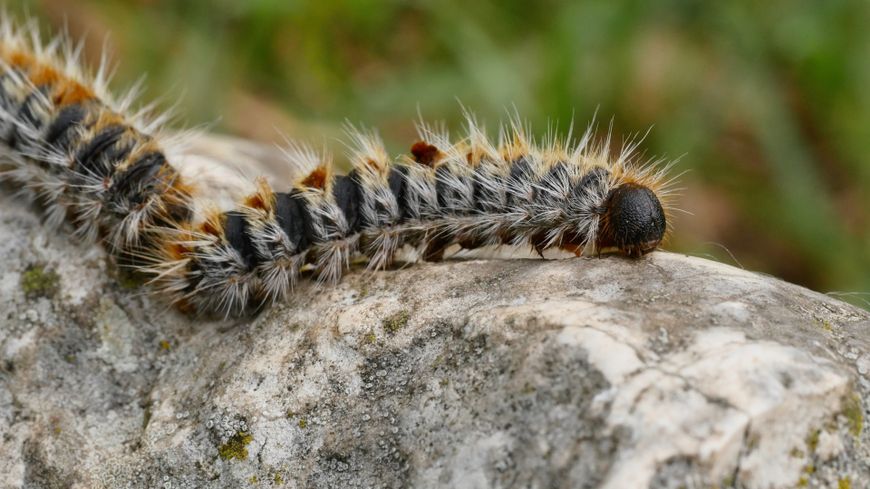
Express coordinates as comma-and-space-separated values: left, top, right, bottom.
596, 183, 667, 257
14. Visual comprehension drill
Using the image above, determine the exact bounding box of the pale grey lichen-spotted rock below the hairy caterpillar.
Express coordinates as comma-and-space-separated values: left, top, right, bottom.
0, 194, 870, 488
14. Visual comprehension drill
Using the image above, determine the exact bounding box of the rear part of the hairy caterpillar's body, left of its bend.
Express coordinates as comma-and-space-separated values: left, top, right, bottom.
0, 17, 190, 253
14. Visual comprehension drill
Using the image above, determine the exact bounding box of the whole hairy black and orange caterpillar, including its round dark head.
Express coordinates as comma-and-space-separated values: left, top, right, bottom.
0, 14, 675, 316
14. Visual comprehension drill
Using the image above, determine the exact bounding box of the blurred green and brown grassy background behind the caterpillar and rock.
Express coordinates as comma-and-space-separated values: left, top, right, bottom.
13, 0, 870, 307
